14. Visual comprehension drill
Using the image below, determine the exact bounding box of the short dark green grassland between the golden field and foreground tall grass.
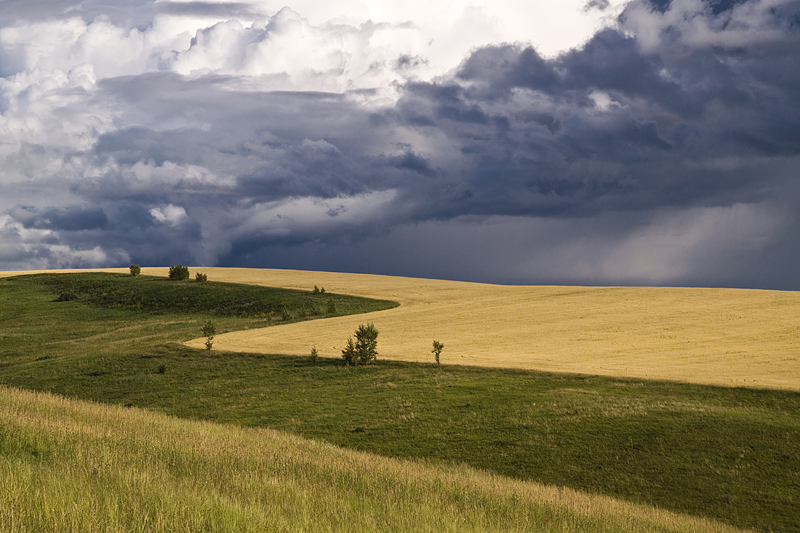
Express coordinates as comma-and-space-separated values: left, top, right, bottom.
0, 274, 800, 531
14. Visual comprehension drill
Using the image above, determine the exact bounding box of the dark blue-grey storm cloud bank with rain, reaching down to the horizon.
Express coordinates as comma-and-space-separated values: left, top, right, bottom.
8, 1, 800, 288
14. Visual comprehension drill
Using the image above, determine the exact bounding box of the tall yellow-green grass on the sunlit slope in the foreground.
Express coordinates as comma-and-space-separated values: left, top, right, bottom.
0, 387, 735, 532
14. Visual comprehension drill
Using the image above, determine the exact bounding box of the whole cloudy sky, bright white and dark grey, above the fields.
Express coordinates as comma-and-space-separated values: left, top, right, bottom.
0, 0, 800, 290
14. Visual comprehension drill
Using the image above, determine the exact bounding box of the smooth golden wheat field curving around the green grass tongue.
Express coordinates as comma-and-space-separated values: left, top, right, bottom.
4, 268, 800, 390
